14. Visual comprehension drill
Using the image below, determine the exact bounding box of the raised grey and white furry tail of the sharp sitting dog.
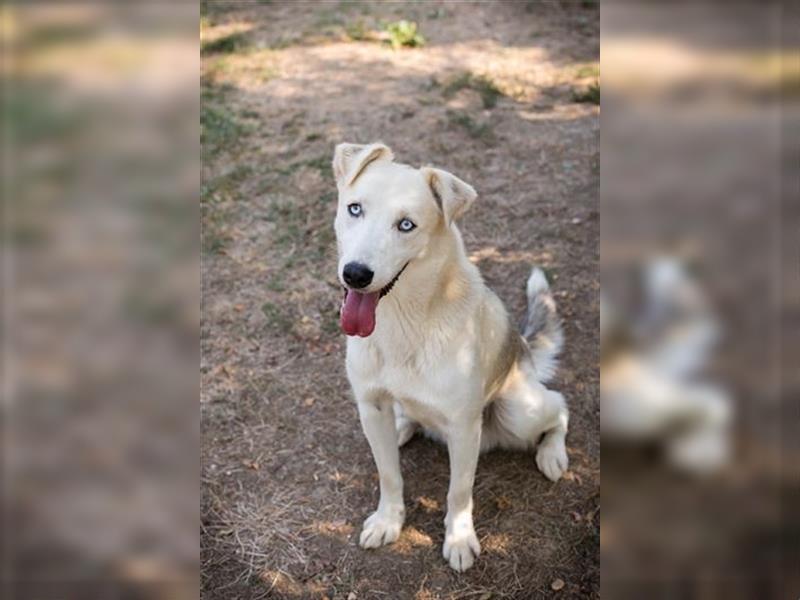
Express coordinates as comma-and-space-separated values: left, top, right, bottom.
522, 267, 564, 382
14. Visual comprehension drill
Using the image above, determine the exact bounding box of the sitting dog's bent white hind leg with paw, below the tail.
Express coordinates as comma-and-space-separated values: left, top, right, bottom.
481, 372, 569, 481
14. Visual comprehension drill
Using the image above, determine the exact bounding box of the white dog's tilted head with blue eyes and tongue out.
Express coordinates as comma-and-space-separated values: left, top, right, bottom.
333, 144, 477, 337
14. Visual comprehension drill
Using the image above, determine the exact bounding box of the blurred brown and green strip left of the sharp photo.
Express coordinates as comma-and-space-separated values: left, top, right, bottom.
0, 3, 200, 599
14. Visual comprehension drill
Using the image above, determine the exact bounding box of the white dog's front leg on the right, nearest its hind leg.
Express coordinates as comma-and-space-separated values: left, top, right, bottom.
442, 415, 482, 571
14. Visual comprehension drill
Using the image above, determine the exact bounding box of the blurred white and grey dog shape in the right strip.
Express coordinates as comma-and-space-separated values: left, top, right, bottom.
600, 257, 731, 473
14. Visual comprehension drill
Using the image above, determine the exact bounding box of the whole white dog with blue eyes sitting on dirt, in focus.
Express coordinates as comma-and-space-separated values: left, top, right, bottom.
333, 144, 568, 571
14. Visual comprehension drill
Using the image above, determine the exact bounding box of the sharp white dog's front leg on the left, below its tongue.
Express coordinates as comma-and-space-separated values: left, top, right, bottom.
358, 394, 405, 548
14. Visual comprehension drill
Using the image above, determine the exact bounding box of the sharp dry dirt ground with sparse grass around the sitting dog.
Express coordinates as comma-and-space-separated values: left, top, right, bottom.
201, 2, 600, 600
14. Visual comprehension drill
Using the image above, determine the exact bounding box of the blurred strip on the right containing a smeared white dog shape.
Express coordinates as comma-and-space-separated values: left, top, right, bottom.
600, 2, 800, 598
